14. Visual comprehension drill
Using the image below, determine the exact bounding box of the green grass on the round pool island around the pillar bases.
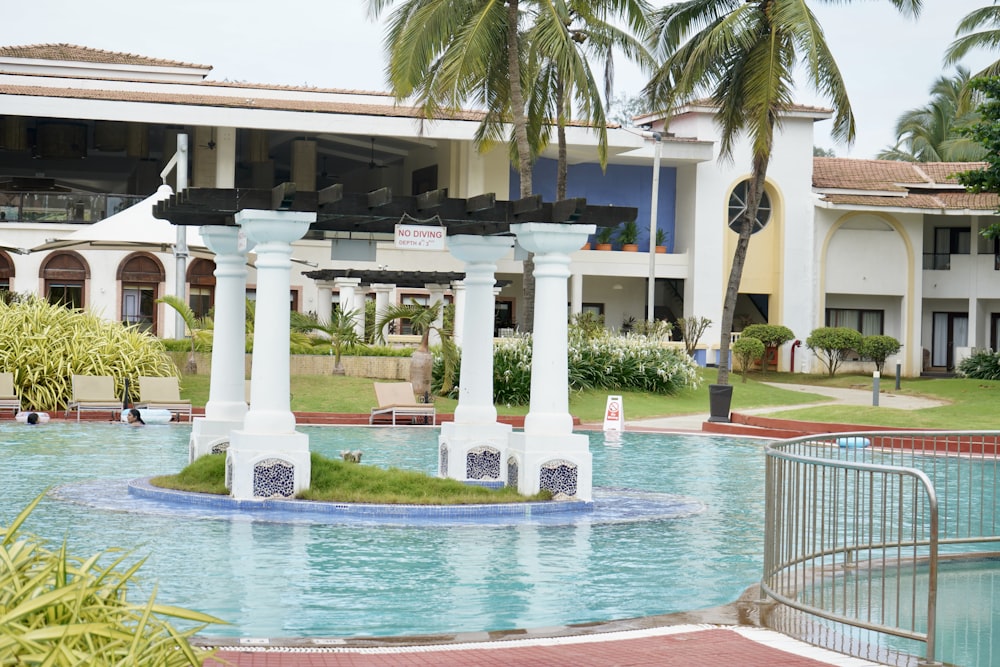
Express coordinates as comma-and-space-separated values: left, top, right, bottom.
150, 452, 551, 505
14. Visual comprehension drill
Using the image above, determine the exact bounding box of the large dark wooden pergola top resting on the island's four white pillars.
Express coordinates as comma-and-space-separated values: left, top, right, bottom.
153, 183, 638, 236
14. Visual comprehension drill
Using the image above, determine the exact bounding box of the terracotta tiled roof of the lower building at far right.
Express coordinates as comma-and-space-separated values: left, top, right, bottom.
813, 157, 1000, 211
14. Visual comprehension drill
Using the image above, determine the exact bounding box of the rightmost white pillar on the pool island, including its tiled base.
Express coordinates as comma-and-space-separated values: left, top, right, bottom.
507, 222, 596, 502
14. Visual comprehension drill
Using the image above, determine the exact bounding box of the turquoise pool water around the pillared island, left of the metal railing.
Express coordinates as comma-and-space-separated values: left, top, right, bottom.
0, 423, 764, 637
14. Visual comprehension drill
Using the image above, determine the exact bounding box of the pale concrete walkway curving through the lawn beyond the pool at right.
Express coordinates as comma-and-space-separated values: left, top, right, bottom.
625, 382, 945, 431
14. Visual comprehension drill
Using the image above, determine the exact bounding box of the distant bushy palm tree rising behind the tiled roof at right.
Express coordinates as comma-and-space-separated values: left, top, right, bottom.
877, 67, 986, 162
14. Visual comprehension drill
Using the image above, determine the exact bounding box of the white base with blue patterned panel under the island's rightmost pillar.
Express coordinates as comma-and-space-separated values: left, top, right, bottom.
507, 432, 594, 502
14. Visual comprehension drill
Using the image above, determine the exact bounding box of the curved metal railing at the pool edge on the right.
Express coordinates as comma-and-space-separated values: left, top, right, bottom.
761, 431, 1000, 665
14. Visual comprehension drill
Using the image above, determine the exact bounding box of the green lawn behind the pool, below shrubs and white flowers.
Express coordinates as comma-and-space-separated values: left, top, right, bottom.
181, 369, 1000, 429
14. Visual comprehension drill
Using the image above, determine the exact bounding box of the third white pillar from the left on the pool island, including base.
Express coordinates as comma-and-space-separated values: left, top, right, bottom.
438, 235, 514, 484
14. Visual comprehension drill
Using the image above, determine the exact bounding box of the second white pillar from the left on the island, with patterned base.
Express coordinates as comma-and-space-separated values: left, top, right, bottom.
226, 209, 316, 499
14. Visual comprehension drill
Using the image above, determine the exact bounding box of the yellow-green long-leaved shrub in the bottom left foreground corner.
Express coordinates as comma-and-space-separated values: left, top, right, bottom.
0, 494, 224, 667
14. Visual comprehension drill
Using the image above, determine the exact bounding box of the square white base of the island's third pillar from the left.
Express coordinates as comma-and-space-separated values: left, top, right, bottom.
438, 422, 511, 484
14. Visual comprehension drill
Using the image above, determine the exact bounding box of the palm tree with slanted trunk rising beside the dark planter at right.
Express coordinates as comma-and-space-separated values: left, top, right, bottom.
646, 0, 921, 392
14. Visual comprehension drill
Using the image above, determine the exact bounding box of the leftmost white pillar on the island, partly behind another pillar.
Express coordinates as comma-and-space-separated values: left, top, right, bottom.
188, 226, 253, 462
